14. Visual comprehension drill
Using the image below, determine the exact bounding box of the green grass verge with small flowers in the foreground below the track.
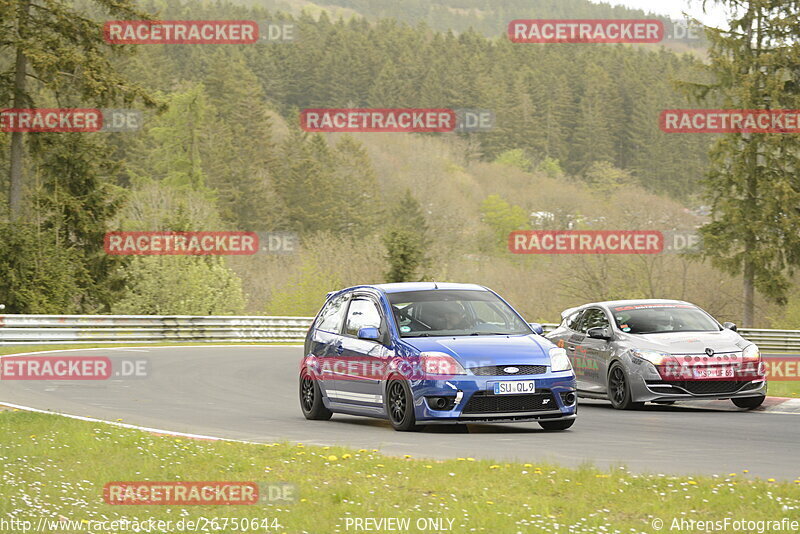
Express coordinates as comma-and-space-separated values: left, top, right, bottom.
0, 410, 800, 533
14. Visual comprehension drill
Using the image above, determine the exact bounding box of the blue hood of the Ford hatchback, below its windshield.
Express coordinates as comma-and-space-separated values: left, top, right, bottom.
403, 334, 555, 367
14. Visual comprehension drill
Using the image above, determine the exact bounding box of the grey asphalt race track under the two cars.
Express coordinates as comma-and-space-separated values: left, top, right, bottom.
0, 346, 800, 480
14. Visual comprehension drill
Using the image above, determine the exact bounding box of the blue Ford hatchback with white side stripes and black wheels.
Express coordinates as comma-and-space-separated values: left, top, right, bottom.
300, 282, 577, 431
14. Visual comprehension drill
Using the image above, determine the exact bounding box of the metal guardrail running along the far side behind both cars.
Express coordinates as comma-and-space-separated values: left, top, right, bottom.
0, 315, 800, 353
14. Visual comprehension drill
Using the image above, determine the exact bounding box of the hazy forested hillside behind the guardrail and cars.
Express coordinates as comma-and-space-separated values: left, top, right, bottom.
0, 0, 800, 327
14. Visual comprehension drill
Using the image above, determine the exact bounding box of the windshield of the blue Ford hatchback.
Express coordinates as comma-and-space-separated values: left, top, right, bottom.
388, 289, 532, 337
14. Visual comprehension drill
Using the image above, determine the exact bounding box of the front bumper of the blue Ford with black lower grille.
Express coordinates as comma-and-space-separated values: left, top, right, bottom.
411, 371, 577, 423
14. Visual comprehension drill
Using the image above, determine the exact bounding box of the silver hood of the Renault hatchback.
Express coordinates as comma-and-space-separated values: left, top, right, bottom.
618, 329, 750, 354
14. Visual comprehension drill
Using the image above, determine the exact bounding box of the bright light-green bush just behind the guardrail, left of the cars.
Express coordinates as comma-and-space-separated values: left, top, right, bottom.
112, 256, 245, 315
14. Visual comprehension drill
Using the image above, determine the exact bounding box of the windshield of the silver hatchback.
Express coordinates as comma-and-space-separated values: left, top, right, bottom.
611, 304, 720, 334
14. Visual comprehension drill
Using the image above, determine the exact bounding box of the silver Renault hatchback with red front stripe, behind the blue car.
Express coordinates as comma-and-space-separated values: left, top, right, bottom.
547, 300, 767, 410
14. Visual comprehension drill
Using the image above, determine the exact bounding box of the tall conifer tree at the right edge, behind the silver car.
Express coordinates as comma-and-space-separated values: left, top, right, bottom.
690, 0, 800, 326
